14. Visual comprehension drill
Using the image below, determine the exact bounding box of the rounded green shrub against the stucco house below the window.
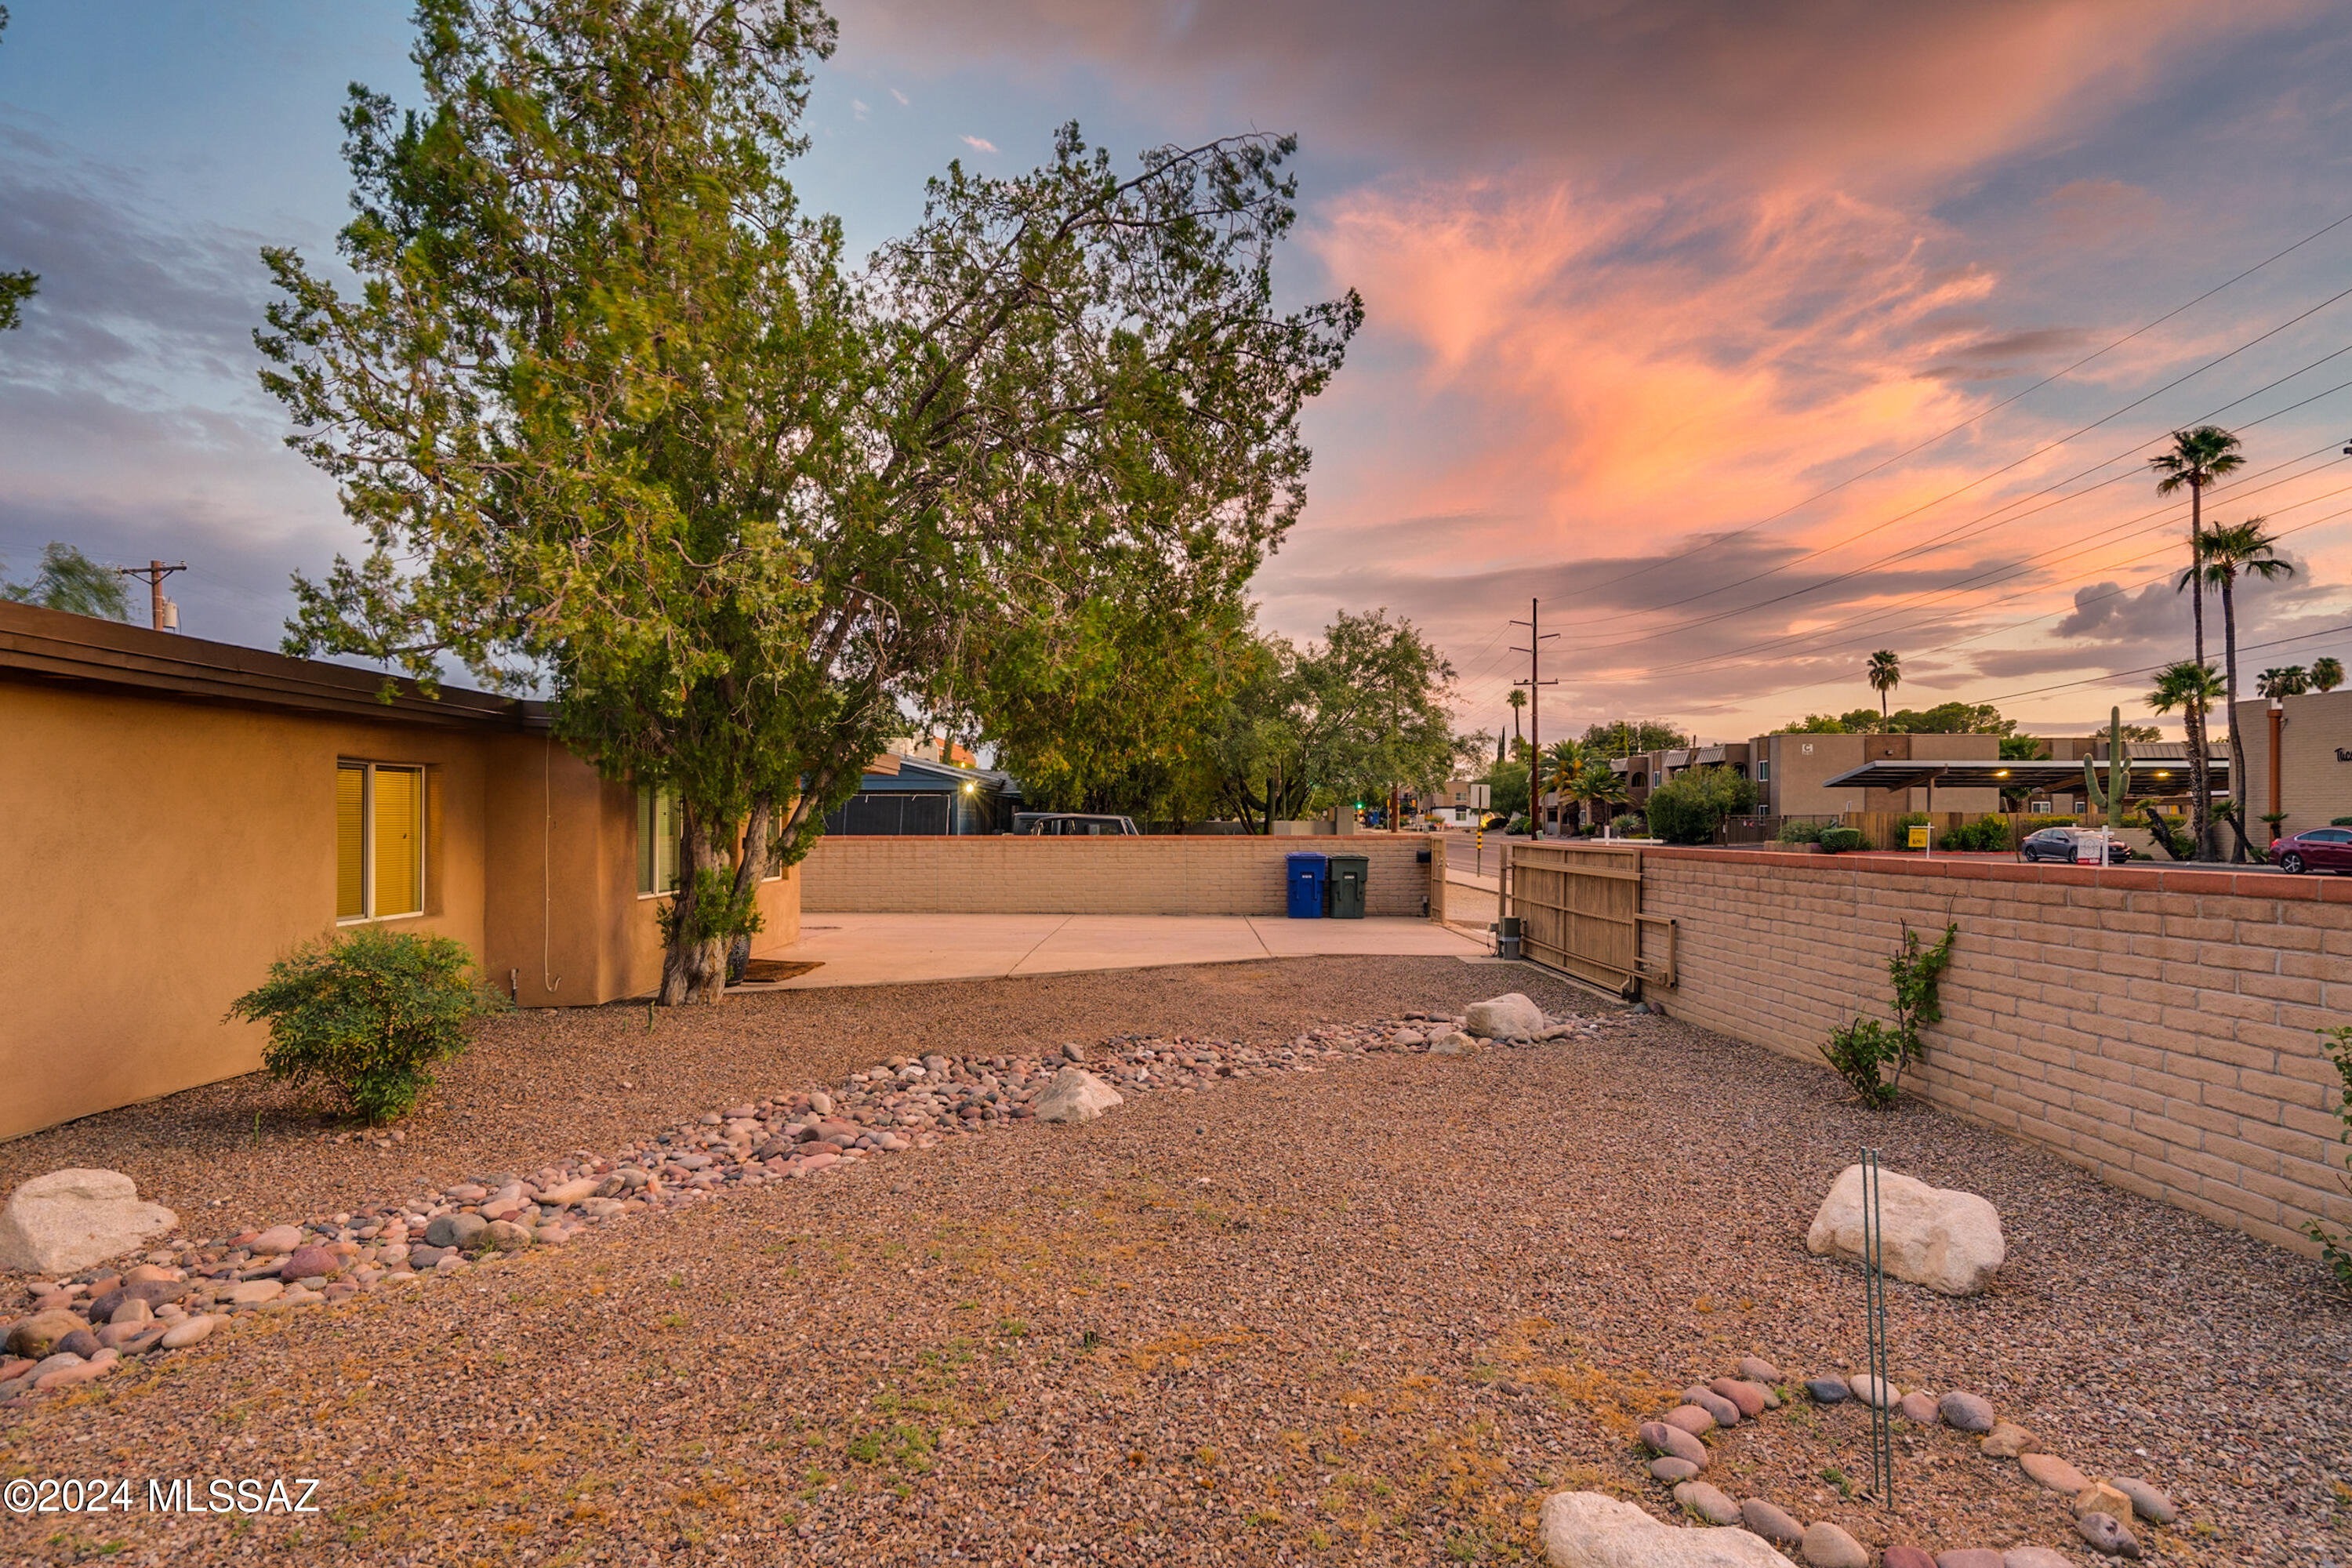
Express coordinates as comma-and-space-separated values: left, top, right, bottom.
223, 926, 506, 1121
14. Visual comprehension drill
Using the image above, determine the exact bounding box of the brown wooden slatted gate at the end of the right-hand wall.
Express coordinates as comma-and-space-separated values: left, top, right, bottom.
1503, 839, 1675, 1001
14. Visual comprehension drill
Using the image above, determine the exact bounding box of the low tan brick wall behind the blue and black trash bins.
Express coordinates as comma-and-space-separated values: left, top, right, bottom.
800, 832, 1442, 916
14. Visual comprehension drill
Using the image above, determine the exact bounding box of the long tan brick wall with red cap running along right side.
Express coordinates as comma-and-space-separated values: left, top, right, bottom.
1642, 848, 2352, 1253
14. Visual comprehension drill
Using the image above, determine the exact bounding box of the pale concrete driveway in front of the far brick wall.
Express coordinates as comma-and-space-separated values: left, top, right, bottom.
755, 914, 1484, 989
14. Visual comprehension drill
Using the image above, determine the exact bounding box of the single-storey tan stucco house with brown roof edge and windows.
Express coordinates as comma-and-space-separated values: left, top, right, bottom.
0, 602, 800, 1138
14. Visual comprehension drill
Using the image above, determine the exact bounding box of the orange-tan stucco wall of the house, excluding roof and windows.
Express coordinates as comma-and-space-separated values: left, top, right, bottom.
0, 682, 800, 1138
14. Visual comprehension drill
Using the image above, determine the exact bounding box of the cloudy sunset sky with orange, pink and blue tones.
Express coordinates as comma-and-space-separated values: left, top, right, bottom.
0, 0, 2352, 739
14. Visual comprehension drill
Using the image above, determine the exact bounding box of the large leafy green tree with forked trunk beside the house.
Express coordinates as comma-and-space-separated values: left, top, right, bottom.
256, 0, 1362, 1004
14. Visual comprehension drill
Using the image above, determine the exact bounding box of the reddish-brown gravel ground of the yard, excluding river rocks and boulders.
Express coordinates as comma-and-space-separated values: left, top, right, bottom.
0, 959, 2352, 1568
